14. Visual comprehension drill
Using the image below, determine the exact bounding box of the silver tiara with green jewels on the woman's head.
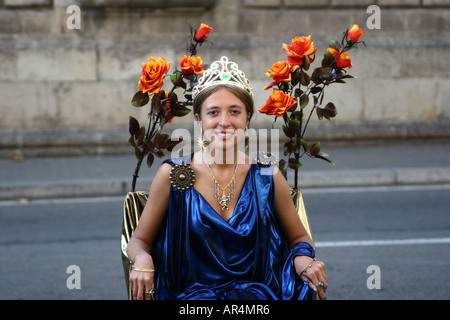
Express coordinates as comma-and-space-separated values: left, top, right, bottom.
192, 57, 254, 100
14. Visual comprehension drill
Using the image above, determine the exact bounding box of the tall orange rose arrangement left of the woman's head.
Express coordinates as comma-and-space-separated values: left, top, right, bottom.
128, 23, 213, 191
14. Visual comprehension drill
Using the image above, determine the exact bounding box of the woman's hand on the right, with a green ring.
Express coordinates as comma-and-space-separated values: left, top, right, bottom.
294, 256, 328, 300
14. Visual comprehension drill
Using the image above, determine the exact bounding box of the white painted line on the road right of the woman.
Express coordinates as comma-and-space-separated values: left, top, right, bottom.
315, 238, 450, 248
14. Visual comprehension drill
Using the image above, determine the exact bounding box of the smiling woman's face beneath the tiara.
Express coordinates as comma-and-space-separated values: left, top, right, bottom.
195, 88, 249, 149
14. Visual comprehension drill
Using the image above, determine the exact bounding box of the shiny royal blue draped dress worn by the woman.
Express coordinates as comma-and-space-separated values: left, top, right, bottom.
152, 158, 315, 300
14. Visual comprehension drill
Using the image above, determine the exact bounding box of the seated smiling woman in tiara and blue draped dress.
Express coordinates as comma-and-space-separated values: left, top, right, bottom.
127, 58, 327, 300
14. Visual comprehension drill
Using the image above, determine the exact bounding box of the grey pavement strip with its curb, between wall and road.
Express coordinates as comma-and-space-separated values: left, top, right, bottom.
0, 142, 450, 201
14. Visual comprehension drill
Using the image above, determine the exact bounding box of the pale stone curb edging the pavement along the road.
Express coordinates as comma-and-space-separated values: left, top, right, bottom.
0, 167, 450, 201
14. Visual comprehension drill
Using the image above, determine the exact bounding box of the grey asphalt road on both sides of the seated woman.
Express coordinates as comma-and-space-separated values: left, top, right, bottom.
0, 185, 450, 300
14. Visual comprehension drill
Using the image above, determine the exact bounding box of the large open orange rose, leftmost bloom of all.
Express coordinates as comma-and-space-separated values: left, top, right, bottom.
138, 56, 170, 93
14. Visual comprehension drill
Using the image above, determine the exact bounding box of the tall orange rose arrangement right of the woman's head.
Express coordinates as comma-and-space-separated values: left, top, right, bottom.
259, 25, 364, 189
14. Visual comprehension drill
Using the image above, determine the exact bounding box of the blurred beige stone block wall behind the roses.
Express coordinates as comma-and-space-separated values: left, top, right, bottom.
0, 0, 450, 157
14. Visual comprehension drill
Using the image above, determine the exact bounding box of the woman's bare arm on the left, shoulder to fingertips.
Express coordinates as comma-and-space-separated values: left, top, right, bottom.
127, 163, 172, 300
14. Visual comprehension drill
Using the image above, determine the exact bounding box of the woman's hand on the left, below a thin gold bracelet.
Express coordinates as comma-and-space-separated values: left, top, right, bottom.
130, 254, 155, 300
